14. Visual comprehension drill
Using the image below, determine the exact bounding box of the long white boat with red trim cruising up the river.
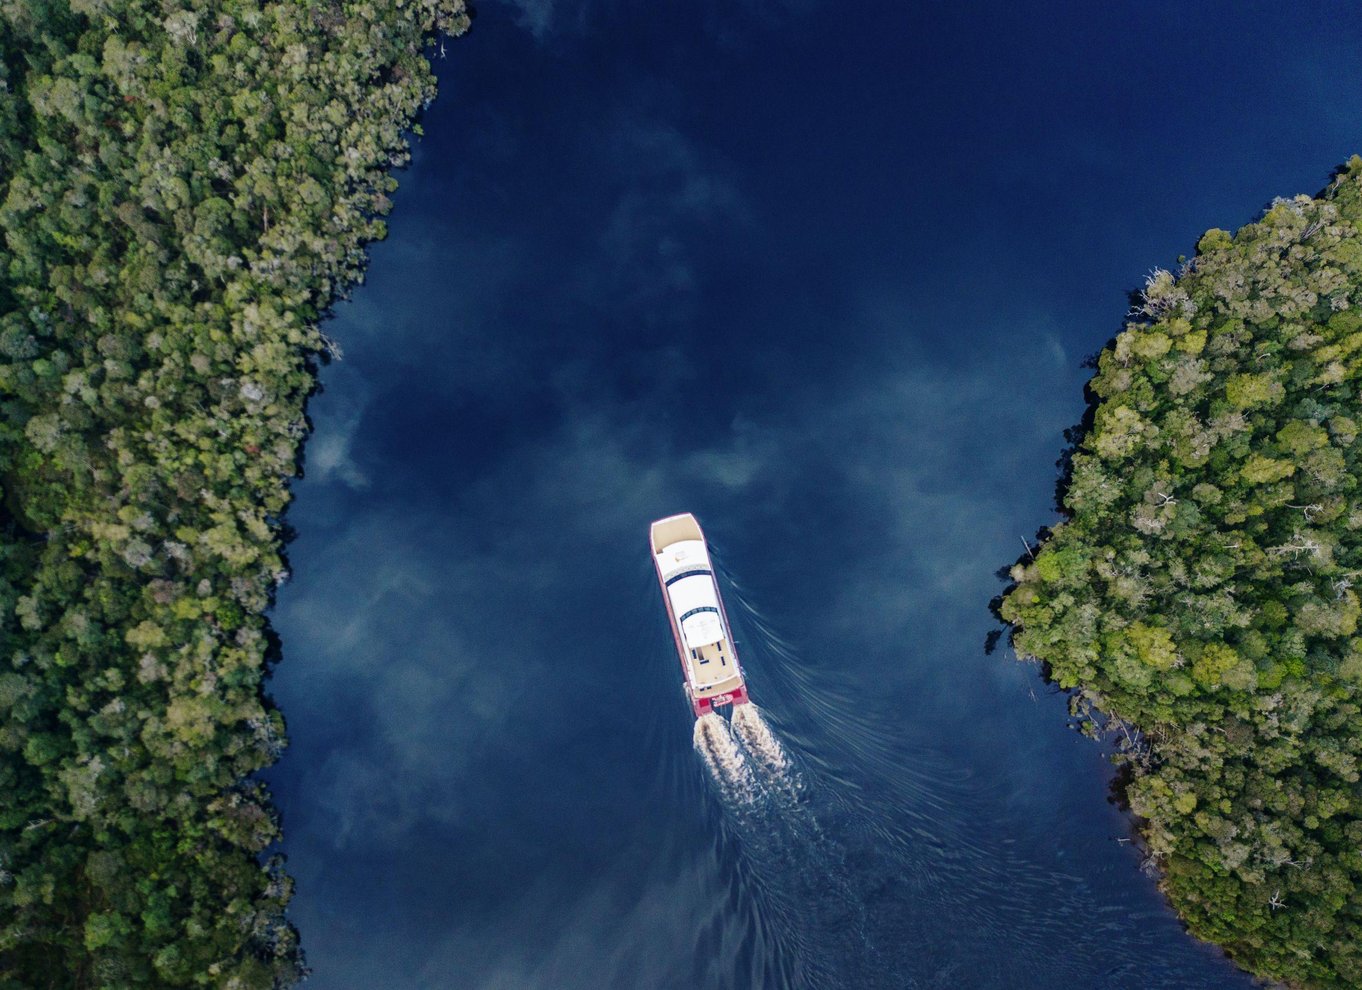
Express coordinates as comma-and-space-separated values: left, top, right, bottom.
650, 512, 748, 718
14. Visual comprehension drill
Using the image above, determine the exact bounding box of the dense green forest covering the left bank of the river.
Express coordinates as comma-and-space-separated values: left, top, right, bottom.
0, 0, 467, 990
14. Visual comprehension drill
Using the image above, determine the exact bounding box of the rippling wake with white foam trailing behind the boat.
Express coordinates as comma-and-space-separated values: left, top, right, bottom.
661, 566, 1247, 990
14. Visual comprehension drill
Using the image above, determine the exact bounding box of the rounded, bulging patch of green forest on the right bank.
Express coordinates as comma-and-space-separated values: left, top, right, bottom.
1001, 158, 1362, 987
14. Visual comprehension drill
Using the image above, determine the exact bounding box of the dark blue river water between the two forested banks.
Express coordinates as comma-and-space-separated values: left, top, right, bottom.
271, 0, 1362, 990
